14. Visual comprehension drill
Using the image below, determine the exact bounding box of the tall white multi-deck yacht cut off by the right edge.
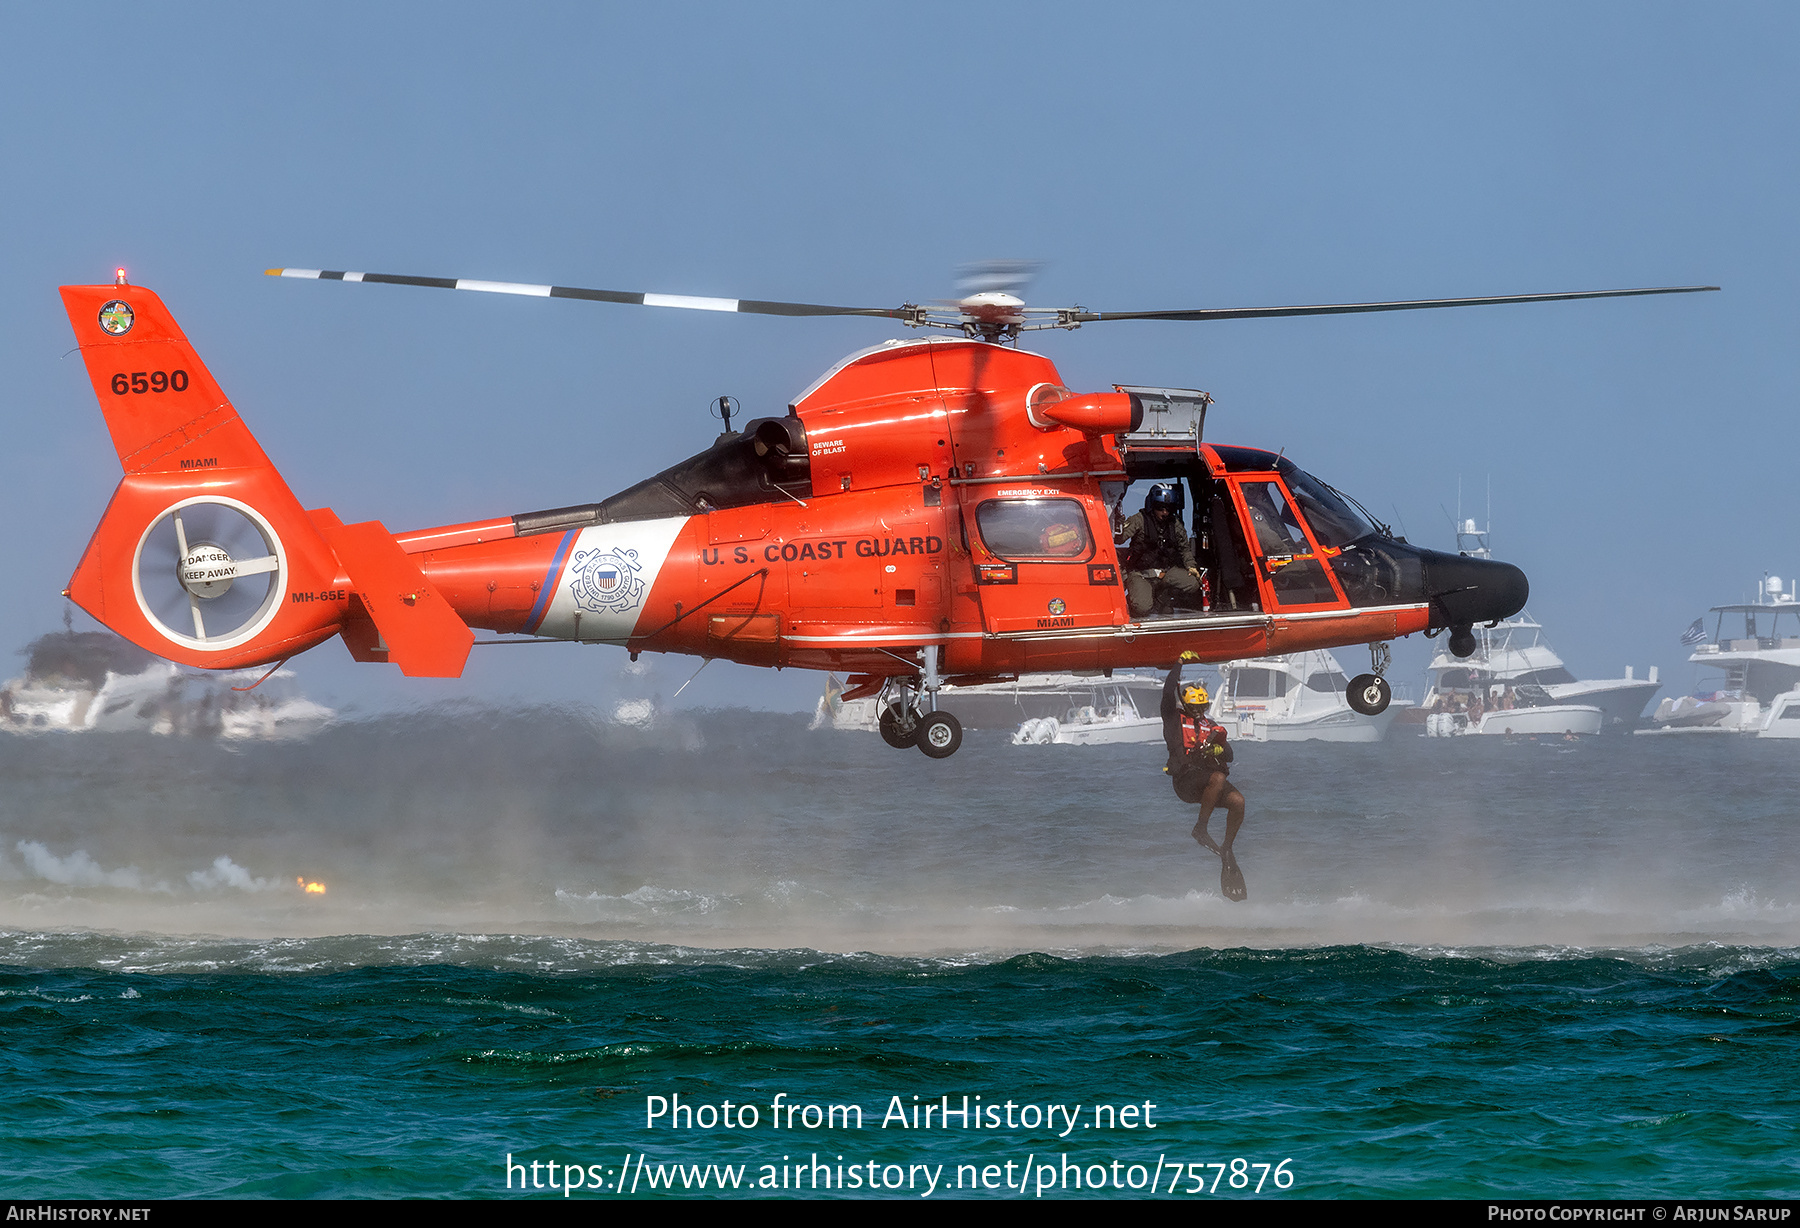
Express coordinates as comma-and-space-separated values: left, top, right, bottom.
1638, 574, 1800, 738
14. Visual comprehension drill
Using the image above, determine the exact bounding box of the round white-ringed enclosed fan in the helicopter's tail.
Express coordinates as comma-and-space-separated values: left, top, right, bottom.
131, 497, 286, 652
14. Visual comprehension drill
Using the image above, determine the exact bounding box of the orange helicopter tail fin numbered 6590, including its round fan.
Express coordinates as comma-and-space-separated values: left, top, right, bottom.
61, 284, 349, 670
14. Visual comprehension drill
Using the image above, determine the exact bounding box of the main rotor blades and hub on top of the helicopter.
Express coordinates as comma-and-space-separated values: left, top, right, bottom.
266, 261, 1719, 342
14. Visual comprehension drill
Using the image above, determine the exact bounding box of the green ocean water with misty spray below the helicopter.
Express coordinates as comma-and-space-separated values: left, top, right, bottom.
0, 708, 1800, 1199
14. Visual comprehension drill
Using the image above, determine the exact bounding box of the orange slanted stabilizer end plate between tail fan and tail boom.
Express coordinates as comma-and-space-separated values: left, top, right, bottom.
320, 520, 475, 679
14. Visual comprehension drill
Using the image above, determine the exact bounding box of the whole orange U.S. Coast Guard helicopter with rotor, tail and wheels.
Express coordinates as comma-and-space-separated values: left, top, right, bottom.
61, 265, 1717, 758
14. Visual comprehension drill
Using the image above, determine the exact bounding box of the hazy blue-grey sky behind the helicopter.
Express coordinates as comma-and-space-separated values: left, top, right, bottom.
0, 2, 1800, 708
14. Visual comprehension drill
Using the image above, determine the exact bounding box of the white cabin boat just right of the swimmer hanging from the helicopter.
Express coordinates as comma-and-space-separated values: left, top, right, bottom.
1208, 650, 1411, 742
